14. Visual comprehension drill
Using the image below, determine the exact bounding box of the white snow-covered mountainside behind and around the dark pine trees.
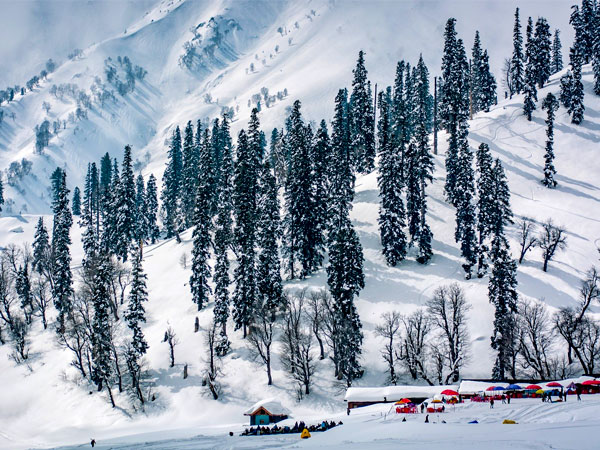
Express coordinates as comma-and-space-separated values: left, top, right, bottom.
0, 0, 600, 449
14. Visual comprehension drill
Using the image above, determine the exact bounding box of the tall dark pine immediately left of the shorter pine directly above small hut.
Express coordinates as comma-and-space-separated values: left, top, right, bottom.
233, 128, 258, 338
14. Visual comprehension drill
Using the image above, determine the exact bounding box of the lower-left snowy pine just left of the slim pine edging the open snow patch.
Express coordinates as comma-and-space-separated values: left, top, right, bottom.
86, 253, 115, 408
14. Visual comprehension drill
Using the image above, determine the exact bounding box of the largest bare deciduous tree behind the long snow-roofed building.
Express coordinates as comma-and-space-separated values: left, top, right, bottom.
427, 283, 471, 384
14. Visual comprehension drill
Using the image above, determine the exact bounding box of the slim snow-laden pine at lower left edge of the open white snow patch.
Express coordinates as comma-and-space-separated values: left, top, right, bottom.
125, 245, 148, 403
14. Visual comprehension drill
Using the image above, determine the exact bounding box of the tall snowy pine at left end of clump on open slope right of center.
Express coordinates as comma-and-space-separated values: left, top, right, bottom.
377, 88, 407, 267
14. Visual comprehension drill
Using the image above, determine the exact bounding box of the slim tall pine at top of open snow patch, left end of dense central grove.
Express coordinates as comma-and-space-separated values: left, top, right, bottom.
161, 127, 183, 242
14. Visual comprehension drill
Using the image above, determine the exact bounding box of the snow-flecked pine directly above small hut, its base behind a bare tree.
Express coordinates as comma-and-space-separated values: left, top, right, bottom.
256, 158, 283, 317
